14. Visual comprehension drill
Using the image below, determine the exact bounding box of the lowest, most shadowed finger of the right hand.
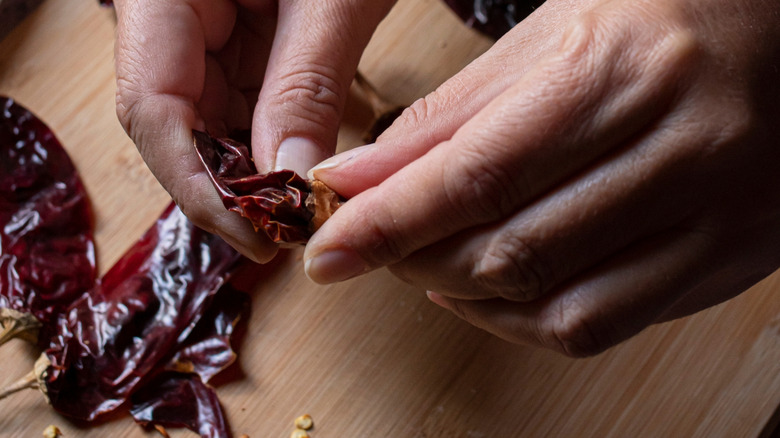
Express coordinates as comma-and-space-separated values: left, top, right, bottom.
429, 226, 714, 357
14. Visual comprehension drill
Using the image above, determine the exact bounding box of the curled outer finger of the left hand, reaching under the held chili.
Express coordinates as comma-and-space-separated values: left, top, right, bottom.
116, 0, 275, 261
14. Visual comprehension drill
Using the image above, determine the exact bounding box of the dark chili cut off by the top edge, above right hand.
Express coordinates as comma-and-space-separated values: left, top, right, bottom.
444, 0, 544, 39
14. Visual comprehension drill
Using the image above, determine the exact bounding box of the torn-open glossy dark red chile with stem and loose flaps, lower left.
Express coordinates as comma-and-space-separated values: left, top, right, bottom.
0, 204, 248, 438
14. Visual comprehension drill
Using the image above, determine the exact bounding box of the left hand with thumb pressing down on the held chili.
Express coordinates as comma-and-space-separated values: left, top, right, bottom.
115, 0, 395, 262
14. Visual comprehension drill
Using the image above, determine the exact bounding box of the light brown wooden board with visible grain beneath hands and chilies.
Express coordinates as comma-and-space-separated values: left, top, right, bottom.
0, 0, 780, 438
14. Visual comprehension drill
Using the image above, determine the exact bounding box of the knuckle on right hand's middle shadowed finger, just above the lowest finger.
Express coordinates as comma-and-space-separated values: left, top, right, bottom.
471, 235, 549, 301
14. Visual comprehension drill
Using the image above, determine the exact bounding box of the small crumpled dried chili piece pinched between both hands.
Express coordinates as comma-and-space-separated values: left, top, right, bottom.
193, 131, 340, 243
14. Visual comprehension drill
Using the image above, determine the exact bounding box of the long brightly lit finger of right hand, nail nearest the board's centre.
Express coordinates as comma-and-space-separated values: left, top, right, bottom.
305, 7, 691, 282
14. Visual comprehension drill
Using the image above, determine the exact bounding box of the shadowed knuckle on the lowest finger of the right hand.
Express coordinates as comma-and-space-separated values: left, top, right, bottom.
541, 299, 615, 358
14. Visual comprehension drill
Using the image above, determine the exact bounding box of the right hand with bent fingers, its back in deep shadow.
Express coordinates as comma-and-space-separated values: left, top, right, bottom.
304, 0, 780, 356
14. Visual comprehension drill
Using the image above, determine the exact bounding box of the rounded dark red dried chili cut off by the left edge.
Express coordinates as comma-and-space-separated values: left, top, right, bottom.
0, 96, 96, 340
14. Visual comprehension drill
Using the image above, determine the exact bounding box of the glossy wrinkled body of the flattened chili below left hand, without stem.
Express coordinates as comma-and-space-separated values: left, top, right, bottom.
45, 204, 242, 421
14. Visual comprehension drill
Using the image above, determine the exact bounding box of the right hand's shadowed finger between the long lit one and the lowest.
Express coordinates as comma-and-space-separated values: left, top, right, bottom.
390, 126, 701, 301
